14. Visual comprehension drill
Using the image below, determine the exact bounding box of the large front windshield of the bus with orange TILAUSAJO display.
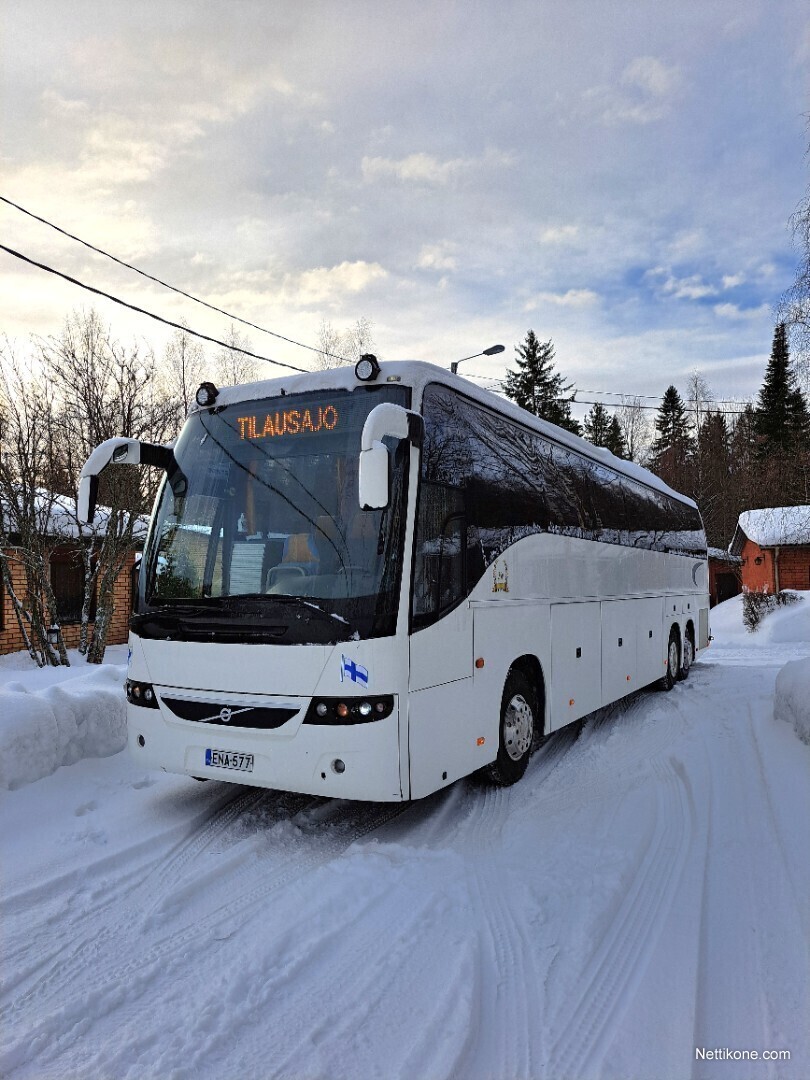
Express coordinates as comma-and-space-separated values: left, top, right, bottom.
135, 386, 409, 644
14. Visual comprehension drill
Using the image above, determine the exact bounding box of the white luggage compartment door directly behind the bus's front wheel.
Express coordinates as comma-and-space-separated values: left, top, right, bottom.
549, 602, 602, 731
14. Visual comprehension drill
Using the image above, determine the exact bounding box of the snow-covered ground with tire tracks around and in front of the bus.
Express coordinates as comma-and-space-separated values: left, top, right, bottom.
0, 594, 810, 1080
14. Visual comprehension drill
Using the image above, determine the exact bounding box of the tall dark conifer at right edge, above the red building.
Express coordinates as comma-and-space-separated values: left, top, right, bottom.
754, 323, 810, 459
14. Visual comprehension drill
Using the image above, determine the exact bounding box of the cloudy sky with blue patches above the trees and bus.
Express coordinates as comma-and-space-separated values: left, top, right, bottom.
0, 0, 810, 412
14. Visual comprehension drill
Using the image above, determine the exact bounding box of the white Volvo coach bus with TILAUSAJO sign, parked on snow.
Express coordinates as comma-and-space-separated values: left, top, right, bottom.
80, 356, 708, 801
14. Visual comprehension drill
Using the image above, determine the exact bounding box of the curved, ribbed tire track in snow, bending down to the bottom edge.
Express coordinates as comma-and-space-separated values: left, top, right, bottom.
548, 757, 694, 1077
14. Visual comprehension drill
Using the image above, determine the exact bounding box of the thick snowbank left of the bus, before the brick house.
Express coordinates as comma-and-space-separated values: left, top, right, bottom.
0, 664, 126, 788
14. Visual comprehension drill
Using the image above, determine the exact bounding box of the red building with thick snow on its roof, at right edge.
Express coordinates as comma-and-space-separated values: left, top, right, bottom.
729, 507, 810, 593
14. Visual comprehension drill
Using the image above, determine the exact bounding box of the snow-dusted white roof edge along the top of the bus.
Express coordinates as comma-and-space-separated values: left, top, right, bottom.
201, 360, 697, 507
